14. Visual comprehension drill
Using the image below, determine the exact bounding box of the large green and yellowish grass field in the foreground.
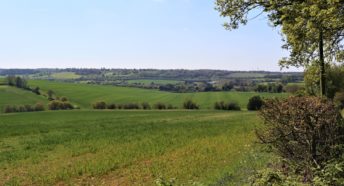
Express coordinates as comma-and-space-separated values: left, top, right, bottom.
0, 111, 269, 185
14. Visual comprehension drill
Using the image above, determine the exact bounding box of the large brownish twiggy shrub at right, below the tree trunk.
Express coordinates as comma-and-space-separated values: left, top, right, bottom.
256, 97, 344, 180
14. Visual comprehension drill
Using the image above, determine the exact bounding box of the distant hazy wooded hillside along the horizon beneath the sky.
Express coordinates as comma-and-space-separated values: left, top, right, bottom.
0, 68, 303, 81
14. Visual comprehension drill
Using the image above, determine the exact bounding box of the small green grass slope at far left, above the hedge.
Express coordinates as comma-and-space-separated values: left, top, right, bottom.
0, 85, 47, 112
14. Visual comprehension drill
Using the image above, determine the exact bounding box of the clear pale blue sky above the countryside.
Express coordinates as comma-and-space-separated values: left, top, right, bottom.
0, 0, 297, 71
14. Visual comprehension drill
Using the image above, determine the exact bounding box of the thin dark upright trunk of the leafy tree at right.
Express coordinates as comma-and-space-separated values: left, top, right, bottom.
319, 31, 326, 97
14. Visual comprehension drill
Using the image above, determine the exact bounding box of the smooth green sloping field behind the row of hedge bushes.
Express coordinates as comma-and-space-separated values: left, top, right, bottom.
29, 80, 287, 109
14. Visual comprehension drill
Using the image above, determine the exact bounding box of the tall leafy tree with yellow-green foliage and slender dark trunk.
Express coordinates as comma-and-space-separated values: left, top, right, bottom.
216, 0, 344, 96
